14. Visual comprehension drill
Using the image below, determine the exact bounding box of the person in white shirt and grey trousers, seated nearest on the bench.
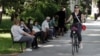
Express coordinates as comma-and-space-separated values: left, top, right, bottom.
11, 20, 34, 51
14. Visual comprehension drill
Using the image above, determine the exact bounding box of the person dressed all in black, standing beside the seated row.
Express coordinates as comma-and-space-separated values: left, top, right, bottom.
56, 7, 66, 35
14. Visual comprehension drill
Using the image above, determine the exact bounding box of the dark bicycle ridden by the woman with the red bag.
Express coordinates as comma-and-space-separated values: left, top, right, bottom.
72, 27, 79, 56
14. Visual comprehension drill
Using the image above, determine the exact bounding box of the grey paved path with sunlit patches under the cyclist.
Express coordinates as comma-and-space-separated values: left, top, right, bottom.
19, 20, 100, 56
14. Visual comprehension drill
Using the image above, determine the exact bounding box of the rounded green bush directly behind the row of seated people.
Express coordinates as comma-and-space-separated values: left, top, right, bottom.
20, 2, 59, 23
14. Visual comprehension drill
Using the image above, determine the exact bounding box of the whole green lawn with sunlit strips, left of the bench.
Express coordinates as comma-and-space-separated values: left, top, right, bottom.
0, 15, 24, 56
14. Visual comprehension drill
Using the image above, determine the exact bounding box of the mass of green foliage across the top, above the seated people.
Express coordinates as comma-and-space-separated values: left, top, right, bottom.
0, 0, 68, 22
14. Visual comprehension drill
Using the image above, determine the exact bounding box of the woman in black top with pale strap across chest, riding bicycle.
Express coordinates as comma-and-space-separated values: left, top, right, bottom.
67, 5, 84, 48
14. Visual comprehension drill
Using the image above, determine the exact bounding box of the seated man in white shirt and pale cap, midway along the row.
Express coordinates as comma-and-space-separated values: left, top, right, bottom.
42, 17, 50, 41
